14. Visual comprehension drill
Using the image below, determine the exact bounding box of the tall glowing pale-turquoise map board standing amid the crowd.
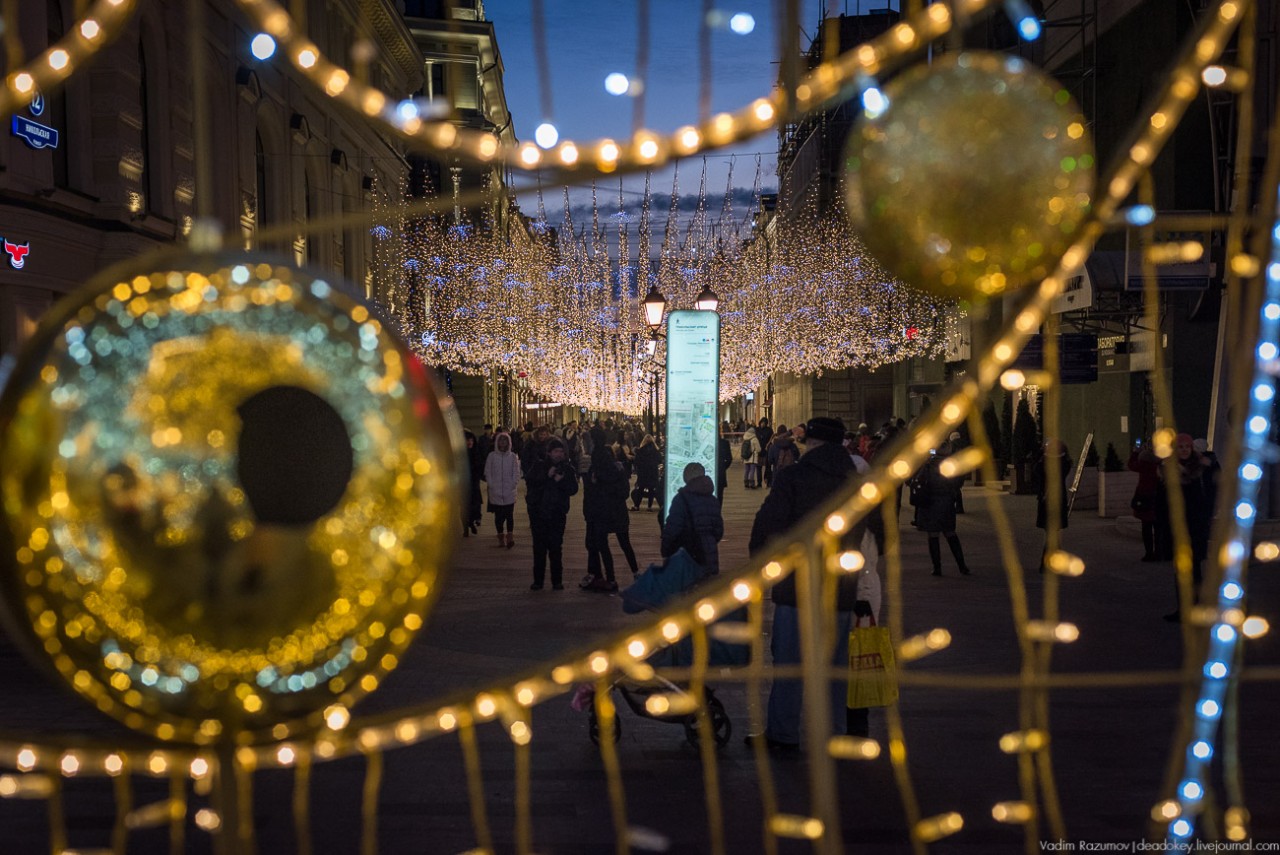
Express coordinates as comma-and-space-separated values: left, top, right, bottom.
662, 311, 719, 509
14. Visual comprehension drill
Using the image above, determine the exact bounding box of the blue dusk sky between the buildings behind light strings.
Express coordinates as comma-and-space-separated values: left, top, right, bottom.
484, 0, 849, 223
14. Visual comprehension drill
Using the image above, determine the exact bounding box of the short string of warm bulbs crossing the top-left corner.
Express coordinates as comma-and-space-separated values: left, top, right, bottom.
0, 0, 137, 116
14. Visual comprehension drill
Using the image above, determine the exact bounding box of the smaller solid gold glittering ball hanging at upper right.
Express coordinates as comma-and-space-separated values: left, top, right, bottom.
845, 52, 1093, 297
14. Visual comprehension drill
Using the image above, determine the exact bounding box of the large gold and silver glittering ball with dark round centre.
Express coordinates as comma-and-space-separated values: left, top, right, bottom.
0, 256, 461, 742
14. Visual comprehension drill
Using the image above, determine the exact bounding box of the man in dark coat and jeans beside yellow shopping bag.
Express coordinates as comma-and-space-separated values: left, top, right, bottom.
748, 417, 874, 751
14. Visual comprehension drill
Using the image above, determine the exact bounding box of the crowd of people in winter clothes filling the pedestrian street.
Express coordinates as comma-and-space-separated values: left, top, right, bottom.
462, 409, 1219, 750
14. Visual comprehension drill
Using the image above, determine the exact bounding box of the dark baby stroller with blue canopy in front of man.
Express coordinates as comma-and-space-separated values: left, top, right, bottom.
585, 549, 750, 746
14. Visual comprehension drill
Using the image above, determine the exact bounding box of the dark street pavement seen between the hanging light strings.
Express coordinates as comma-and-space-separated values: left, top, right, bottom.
0, 478, 1280, 854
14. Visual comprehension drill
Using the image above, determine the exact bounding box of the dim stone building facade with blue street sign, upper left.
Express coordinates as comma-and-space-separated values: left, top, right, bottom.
0, 0, 422, 352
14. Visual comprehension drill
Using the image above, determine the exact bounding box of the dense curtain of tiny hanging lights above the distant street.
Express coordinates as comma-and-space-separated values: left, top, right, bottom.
384, 168, 943, 415
